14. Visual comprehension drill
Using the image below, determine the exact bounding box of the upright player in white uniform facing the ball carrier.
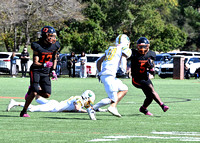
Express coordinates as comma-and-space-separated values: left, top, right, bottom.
93, 34, 131, 117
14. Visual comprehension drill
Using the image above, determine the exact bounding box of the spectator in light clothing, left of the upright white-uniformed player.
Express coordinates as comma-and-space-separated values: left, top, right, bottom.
79, 52, 87, 78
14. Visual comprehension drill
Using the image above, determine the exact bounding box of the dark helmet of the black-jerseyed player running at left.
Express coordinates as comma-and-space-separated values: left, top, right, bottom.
41, 26, 57, 44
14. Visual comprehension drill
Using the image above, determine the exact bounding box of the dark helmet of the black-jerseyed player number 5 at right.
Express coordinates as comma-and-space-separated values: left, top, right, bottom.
137, 37, 150, 55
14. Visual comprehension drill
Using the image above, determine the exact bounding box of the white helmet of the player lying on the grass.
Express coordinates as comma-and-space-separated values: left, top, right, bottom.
81, 90, 95, 108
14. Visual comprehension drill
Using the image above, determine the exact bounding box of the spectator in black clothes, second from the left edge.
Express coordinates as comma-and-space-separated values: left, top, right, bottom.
21, 45, 30, 78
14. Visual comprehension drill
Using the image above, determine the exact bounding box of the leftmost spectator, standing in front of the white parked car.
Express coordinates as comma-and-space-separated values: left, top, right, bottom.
10, 52, 19, 78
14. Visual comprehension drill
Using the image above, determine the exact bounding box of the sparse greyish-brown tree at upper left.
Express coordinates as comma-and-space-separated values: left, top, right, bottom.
0, 0, 84, 49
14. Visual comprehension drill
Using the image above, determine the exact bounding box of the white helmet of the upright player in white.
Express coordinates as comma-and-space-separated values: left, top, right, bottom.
115, 34, 131, 47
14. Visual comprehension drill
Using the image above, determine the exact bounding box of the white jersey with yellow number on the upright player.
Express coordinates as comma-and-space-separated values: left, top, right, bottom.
100, 45, 127, 77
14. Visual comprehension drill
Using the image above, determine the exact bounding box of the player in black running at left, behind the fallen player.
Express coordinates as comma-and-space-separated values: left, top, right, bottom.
20, 26, 60, 117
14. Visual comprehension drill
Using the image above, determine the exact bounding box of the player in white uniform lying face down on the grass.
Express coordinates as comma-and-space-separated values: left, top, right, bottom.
7, 90, 97, 120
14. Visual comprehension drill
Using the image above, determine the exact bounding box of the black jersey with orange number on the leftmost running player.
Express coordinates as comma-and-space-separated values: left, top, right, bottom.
31, 41, 60, 73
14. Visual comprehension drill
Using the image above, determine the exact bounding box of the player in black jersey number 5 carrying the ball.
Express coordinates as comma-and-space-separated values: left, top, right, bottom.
131, 37, 169, 116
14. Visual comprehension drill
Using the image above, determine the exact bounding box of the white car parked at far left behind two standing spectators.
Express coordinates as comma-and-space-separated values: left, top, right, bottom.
0, 52, 33, 74
